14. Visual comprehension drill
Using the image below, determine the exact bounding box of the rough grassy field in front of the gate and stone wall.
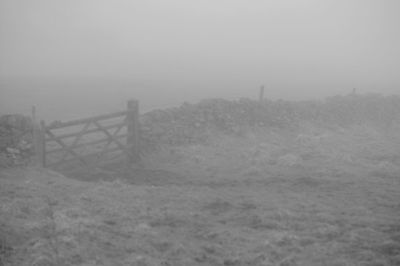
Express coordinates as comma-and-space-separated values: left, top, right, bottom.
0, 123, 400, 266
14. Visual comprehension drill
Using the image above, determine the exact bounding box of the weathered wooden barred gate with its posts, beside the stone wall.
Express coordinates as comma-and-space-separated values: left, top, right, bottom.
34, 100, 139, 168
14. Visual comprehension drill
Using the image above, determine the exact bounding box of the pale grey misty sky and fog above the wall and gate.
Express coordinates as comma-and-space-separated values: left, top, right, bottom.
0, 0, 400, 120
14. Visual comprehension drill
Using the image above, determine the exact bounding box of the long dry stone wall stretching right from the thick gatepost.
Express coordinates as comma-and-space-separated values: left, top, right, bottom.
141, 94, 400, 149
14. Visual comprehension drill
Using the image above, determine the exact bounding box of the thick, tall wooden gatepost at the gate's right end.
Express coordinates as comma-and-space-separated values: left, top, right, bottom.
126, 100, 140, 167
